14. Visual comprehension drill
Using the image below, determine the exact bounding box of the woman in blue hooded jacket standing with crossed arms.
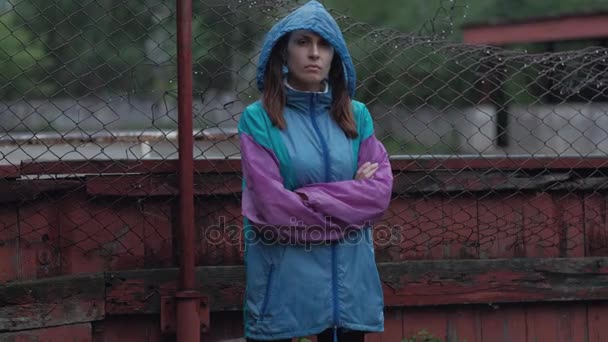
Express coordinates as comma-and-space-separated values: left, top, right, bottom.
239, 1, 393, 341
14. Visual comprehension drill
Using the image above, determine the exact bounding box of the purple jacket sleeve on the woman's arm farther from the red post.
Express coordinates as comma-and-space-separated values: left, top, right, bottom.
295, 134, 393, 228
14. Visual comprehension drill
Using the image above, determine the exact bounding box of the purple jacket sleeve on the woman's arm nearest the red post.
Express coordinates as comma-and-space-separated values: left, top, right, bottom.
240, 132, 343, 241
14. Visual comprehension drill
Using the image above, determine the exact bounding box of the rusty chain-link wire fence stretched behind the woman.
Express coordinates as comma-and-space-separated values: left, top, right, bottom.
0, 0, 608, 279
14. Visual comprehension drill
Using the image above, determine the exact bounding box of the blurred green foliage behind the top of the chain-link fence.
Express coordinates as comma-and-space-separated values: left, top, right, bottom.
0, 0, 608, 103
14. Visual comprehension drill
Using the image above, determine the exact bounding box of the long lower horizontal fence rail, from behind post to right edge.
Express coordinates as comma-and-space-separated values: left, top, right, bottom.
106, 258, 608, 314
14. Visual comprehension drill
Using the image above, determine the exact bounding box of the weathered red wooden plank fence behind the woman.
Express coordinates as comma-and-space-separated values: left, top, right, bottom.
0, 158, 608, 341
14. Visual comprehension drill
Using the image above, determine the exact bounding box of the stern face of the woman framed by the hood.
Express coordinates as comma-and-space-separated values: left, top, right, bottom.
287, 30, 334, 91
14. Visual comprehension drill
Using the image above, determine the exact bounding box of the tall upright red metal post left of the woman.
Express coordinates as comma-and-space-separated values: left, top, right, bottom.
175, 0, 200, 342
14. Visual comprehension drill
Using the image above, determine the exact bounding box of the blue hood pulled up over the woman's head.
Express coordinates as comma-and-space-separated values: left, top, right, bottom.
257, 0, 357, 98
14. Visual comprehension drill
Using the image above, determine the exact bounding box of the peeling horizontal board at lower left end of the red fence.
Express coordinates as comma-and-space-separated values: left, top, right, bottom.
0, 274, 105, 331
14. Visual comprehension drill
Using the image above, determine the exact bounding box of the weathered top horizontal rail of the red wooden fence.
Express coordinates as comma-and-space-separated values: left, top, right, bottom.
5, 171, 608, 199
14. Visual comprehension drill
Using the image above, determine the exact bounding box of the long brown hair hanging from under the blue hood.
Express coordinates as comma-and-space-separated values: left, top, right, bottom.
262, 34, 359, 139
